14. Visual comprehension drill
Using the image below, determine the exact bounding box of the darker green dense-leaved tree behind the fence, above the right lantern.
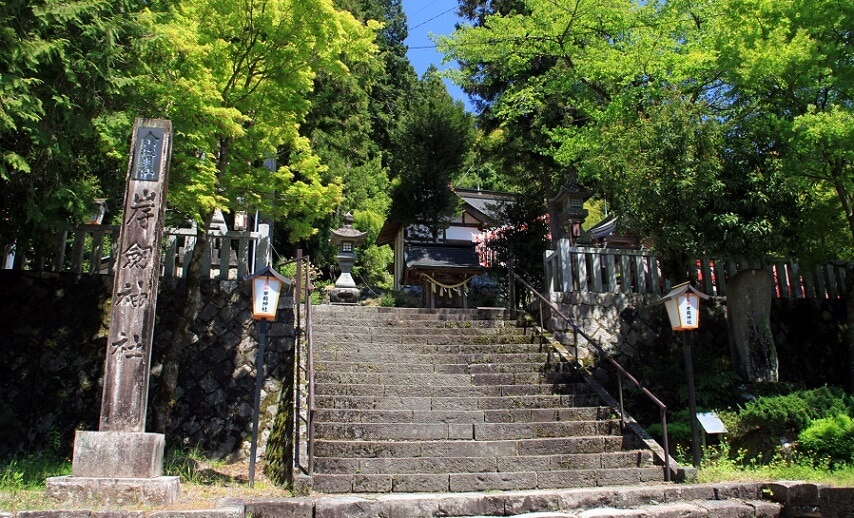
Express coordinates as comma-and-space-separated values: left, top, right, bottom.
583, 93, 724, 275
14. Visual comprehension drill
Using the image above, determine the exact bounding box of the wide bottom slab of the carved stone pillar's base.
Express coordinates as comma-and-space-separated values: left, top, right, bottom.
45, 476, 180, 506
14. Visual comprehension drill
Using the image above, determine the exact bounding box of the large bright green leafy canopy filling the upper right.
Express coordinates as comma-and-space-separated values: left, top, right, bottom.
438, 0, 854, 268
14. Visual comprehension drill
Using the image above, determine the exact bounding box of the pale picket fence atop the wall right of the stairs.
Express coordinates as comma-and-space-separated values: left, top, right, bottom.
544, 239, 845, 299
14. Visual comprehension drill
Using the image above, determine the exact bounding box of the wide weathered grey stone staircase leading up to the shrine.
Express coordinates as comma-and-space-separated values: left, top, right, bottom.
304, 305, 664, 493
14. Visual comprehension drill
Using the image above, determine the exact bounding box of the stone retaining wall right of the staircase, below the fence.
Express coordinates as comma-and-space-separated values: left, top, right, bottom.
548, 293, 848, 386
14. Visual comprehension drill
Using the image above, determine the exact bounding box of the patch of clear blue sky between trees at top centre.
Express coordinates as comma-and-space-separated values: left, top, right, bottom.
403, 0, 472, 111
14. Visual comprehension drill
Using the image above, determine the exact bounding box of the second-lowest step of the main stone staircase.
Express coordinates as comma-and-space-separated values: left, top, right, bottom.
314, 450, 652, 475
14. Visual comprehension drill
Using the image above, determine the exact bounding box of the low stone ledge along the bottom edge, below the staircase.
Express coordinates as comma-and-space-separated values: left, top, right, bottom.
10, 482, 854, 518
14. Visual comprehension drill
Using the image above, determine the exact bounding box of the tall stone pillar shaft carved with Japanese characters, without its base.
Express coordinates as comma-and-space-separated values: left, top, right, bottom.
100, 119, 172, 432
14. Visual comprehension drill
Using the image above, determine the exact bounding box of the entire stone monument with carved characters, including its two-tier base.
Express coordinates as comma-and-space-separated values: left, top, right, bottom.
46, 119, 179, 505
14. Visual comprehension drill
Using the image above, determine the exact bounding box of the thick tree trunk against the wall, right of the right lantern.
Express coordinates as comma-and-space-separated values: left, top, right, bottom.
727, 270, 779, 383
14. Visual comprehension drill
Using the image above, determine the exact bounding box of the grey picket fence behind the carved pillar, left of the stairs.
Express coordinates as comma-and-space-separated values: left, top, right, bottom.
2, 225, 272, 279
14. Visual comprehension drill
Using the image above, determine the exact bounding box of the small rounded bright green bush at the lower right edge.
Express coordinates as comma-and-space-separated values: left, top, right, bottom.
798, 414, 854, 469
